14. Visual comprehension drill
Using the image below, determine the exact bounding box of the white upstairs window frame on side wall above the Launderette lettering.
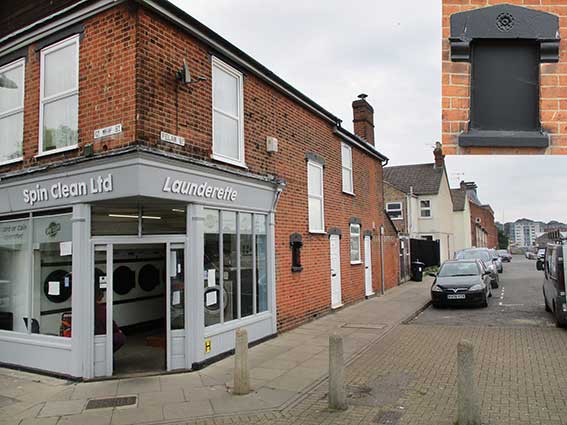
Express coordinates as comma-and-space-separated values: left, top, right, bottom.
211, 56, 246, 168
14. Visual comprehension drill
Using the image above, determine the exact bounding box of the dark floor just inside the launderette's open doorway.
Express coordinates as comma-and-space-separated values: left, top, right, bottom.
113, 327, 166, 376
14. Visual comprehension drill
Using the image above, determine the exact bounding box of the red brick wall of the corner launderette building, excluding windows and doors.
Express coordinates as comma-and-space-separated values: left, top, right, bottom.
0, 4, 384, 330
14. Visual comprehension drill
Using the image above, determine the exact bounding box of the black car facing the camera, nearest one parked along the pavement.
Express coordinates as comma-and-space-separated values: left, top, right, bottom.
431, 260, 492, 307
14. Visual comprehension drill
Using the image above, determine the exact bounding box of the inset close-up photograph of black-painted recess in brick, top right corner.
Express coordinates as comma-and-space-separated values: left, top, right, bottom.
442, 0, 567, 155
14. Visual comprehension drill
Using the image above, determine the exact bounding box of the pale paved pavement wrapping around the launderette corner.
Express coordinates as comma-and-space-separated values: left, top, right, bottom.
0, 278, 430, 425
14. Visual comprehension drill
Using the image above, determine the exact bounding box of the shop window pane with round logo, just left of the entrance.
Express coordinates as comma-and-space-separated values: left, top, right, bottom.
32, 214, 73, 337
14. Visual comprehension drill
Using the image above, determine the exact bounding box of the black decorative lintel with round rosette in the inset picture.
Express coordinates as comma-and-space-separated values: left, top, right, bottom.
449, 4, 560, 62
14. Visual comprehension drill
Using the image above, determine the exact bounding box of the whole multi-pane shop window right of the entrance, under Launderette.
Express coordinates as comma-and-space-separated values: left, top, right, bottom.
203, 209, 268, 326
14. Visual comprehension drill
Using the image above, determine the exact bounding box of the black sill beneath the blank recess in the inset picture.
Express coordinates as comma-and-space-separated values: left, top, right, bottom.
459, 130, 550, 148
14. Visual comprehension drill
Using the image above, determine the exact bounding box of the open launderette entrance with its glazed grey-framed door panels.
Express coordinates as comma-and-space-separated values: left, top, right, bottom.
93, 242, 187, 376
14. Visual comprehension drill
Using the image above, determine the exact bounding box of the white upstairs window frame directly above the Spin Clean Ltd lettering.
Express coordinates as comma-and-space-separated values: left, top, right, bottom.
36, 34, 80, 156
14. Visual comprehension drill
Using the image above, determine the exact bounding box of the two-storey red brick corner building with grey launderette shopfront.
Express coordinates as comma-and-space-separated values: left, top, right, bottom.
0, 0, 390, 378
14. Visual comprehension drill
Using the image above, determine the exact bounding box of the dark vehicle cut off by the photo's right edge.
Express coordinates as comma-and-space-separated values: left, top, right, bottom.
536, 244, 567, 328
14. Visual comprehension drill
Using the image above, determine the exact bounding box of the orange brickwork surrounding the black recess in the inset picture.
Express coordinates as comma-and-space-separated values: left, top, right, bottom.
442, 0, 567, 155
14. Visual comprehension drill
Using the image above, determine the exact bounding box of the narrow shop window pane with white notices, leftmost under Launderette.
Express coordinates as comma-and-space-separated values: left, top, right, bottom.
203, 210, 220, 326
